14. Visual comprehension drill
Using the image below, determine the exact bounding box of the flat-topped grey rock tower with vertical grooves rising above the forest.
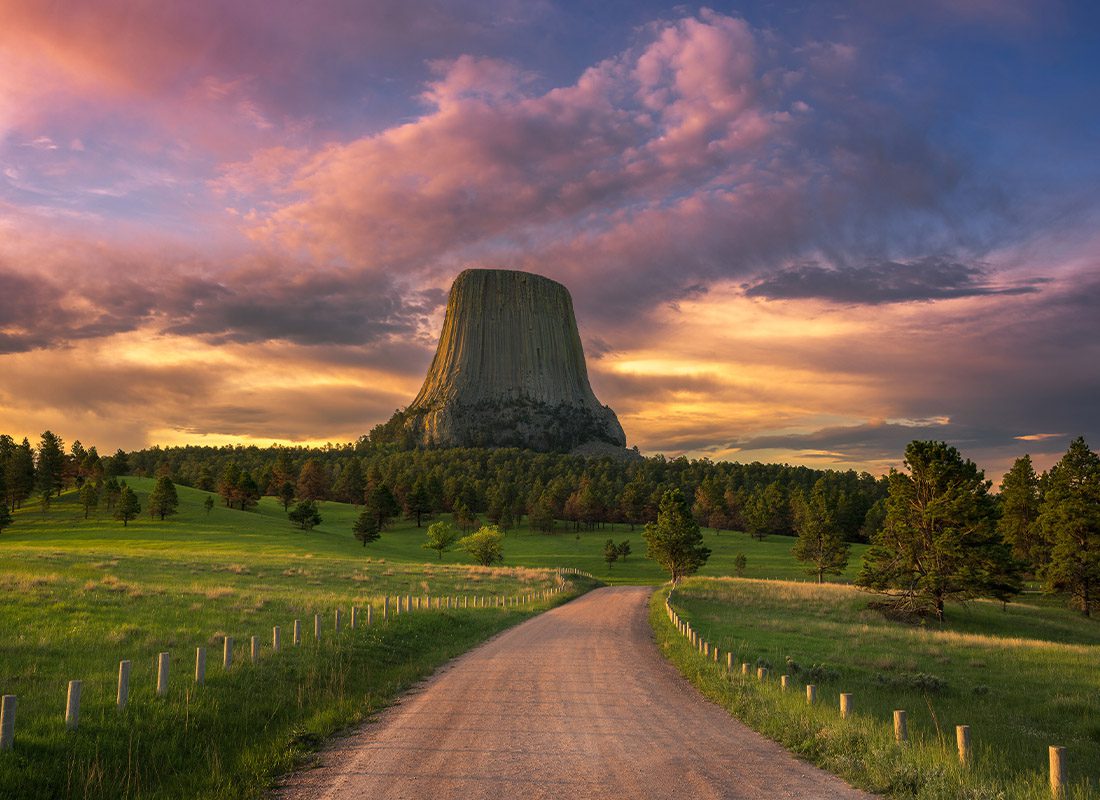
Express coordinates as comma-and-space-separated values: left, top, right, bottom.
403, 270, 626, 450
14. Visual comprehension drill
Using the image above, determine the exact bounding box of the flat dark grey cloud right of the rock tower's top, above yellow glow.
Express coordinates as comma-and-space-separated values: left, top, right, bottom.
745, 256, 1048, 305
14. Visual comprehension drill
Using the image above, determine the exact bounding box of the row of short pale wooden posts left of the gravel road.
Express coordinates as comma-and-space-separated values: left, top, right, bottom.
0, 568, 591, 752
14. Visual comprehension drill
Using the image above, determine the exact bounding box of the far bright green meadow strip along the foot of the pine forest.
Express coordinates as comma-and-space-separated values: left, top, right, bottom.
0, 478, 866, 585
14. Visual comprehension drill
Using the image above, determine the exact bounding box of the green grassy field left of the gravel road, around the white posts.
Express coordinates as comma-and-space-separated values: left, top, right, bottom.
0, 479, 583, 800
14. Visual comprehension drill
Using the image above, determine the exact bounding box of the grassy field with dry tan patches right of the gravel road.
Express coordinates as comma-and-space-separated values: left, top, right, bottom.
651, 578, 1100, 800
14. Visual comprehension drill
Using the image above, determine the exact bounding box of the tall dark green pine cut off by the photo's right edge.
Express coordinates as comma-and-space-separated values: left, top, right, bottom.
1038, 437, 1100, 616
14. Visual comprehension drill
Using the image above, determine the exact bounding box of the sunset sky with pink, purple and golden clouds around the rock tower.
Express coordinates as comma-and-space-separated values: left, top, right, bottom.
0, 0, 1100, 480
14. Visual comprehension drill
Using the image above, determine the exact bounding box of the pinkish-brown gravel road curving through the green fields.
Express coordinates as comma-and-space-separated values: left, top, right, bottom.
275, 587, 870, 800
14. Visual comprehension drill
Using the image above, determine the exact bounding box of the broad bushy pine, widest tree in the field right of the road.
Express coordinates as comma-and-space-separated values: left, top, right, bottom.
856, 441, 1013, 621
